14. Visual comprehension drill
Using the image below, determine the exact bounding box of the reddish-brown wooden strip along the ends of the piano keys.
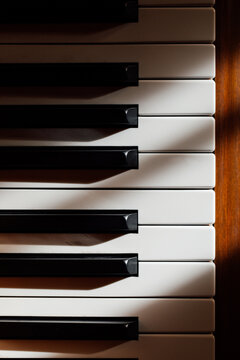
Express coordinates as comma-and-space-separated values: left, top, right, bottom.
216, 0, 240, 359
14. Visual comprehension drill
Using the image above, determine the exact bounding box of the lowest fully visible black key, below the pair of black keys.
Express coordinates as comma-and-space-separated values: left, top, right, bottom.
0, 316, 138, 340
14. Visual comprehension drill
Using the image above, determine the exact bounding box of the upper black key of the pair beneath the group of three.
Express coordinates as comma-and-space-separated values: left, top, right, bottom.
0, 210, 138, 234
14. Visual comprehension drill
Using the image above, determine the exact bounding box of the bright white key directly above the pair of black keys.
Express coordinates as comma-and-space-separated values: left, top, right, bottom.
0, 189, 215, 225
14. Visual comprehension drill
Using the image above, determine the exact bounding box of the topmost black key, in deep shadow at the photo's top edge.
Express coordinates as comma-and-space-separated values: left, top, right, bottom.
0, 0, 138, 24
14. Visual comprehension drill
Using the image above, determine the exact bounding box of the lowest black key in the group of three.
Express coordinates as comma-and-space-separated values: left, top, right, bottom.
0, 146, 139, 170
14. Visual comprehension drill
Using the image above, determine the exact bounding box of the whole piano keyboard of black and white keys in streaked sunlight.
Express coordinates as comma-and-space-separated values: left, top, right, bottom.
0, 0, 215, 360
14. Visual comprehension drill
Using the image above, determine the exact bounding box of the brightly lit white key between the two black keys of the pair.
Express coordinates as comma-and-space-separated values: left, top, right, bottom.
0, 226, 215, 261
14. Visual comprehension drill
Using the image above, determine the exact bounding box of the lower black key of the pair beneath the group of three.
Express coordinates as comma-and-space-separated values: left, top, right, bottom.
0, 254, 138, 278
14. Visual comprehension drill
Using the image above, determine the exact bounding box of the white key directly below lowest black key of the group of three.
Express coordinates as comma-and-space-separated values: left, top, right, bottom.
0, 153, 215, 189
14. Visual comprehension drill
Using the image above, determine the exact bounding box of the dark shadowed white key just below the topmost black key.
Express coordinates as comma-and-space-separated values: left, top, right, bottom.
0, 7, 215, 44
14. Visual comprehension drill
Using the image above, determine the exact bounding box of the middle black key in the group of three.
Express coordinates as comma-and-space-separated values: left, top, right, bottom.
0, 105, 138, 129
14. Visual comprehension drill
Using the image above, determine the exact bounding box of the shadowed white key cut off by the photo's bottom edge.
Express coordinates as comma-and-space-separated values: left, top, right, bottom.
0, 334, 214, 360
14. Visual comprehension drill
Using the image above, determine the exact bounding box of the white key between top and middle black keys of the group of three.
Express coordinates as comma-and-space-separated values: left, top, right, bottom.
0, 80, 215, 116
